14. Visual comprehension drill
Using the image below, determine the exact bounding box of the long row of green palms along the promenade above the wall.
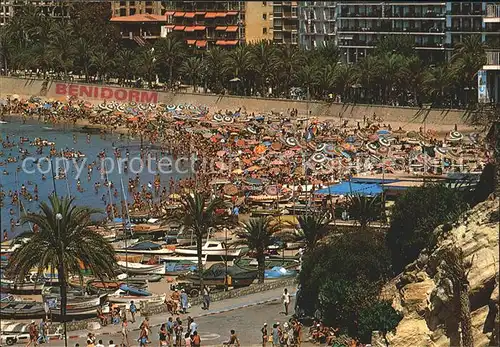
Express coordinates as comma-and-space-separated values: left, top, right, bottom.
0, 6, 486, 106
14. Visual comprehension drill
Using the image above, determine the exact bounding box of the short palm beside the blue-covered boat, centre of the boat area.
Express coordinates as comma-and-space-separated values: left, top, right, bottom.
234, 217, 281, 283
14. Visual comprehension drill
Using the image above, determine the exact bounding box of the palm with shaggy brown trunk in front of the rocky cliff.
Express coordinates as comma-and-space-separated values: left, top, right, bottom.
441, 247, 474, 347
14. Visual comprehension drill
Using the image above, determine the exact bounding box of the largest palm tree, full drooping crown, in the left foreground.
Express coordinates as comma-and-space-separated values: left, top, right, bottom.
7, 195, 117, 345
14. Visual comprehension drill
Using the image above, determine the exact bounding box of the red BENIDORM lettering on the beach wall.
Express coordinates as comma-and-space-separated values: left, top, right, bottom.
56, 83, 158, 103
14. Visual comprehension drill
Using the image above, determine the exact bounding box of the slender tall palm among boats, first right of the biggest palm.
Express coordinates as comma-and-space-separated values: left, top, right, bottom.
168, 192, 225, 293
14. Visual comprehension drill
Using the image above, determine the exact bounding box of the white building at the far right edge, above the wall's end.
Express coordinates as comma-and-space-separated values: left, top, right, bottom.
477, 2, 500, 104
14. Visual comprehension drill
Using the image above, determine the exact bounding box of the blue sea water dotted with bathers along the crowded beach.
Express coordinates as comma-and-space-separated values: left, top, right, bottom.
0, 118, 189, 238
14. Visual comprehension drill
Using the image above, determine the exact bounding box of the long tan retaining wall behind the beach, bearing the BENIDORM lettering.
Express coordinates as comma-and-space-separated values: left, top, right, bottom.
0, 77, 465, 125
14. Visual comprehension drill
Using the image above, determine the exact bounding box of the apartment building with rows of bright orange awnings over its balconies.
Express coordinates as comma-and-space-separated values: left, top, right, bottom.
165, 1, 246, 49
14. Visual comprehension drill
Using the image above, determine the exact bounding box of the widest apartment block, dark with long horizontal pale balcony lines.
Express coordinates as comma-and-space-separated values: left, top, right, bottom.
336, 1, 446, 63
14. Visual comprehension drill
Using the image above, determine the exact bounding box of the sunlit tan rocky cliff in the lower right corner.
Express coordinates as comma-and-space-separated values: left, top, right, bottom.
387, 198, 499, 347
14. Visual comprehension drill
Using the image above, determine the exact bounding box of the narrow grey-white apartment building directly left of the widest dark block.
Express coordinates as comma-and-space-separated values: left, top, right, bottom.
299, 1, 336, 49
